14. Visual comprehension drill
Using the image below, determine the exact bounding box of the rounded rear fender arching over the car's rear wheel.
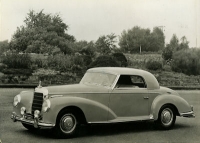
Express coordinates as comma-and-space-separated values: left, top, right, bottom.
151, 94, 191, 120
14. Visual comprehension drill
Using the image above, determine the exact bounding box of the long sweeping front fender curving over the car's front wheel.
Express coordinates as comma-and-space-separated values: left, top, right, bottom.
43, 97, 116, 123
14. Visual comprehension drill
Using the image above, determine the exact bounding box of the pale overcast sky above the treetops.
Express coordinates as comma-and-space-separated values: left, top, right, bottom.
0, 0, 200, 47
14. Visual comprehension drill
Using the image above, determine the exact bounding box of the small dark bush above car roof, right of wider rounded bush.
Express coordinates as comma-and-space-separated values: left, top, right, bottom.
112, 53, 128, 67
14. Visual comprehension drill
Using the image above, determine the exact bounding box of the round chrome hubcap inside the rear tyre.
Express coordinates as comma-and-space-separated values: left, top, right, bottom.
161, 108, 174, 126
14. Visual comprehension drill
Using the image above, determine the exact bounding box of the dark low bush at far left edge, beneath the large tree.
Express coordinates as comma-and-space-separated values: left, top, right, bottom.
2, 53, 31, 69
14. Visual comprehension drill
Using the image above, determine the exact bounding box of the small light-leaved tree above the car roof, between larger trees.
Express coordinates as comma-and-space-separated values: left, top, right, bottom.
95, 33, 117, 54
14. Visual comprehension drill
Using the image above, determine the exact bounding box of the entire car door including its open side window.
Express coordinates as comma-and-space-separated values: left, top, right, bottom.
109, 75, 149, 119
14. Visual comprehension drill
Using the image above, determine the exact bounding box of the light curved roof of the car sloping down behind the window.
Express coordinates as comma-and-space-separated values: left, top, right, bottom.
88, 67, 160, 89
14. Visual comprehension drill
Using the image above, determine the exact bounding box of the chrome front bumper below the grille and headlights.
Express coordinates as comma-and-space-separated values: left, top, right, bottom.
11, 112, 55, 129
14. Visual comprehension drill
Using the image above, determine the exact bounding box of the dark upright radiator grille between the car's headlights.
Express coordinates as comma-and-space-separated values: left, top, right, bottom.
32, 92, 43, 114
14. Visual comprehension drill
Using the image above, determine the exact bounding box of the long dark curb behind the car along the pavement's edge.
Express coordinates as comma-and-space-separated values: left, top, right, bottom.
0, 84, 200, 90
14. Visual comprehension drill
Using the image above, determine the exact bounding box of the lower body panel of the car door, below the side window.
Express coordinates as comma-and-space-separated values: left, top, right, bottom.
109, 88, 148, 117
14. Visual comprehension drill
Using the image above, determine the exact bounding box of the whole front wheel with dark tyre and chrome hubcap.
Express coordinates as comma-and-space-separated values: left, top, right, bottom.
54, 110, 78, 138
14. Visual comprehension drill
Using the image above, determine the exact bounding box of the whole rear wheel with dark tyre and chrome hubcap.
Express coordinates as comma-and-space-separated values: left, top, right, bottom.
155, 105, 176, 130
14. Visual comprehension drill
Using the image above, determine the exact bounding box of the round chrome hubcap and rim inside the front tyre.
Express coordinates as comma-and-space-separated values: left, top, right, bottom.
60, 114, 77, 134
